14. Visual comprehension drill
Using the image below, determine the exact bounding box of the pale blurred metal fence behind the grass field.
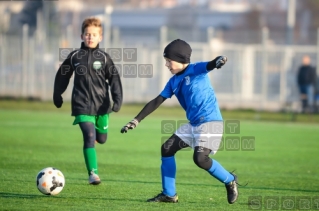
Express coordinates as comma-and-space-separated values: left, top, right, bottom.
0, 26, 319, 110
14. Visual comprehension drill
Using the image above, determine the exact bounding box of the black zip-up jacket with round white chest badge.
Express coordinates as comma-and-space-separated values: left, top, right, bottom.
53, 42, 123, 116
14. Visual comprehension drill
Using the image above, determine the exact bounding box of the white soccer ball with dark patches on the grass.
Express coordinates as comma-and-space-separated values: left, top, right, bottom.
36, 167, 65, 195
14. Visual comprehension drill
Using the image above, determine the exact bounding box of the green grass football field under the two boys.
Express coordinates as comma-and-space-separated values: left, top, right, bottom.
0, 102, 319, 210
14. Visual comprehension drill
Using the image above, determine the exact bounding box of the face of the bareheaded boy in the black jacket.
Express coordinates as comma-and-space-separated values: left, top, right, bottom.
81, 26, 102, 48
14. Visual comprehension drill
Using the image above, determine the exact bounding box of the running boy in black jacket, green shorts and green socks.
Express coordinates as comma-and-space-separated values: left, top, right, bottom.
53, 18, 123, 185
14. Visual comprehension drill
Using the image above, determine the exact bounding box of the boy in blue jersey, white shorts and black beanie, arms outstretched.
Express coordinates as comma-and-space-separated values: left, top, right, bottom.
121, 39, 238, 204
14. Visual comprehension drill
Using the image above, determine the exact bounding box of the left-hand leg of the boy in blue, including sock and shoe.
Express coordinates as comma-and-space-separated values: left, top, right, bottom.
147, 134, 189, 202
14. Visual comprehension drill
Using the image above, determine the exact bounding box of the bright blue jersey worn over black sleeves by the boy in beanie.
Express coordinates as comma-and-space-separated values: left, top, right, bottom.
160, 62, 223, 126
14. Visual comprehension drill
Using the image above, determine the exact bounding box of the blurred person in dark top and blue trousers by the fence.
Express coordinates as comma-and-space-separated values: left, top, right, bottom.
297, 55, 317, 113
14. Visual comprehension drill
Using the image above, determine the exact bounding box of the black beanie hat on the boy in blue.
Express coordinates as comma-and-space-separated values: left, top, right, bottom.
163, 39, 192, 64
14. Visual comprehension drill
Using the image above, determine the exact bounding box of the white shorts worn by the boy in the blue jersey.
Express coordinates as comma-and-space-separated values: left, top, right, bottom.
175, 121, 224, 154
